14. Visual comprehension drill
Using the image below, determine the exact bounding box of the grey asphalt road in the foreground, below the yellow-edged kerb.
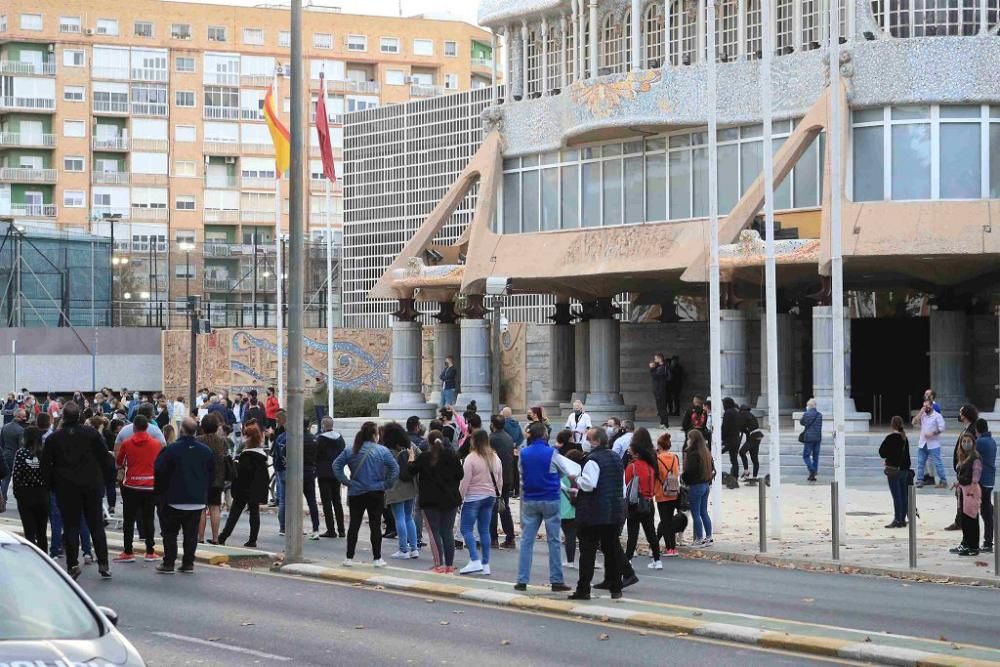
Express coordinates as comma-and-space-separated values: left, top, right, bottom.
80, 563, 833, 666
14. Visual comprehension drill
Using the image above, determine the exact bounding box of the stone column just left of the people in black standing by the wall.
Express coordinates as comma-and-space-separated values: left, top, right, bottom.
584, 299, 635, 424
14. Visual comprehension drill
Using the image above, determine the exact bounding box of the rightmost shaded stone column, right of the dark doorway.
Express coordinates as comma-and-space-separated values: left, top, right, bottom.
928, 310, 969, 417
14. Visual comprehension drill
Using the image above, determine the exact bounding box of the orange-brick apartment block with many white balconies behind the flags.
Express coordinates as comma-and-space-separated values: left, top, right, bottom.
0, 0, 494, 325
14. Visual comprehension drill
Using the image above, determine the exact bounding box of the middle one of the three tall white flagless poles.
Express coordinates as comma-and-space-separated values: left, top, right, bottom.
760, 0, 791, 539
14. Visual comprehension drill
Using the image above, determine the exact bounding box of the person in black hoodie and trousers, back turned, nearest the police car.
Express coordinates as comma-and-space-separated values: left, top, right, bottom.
41, 401, 112, 579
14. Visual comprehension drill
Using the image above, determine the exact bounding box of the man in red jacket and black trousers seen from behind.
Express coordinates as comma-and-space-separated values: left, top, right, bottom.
115, 414, 161, 563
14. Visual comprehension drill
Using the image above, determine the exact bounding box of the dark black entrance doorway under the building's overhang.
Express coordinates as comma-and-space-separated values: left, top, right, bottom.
851, 317, 931, 424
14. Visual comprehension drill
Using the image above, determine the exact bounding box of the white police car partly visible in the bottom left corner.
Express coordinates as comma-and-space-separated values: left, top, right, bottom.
0, 530, 145, 667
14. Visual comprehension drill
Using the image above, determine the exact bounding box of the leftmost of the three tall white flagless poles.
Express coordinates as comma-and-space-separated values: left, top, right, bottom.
705, 0, 722, 528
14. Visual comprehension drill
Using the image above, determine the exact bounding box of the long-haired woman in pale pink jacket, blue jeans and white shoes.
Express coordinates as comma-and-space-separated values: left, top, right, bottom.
459, 429, 503, 574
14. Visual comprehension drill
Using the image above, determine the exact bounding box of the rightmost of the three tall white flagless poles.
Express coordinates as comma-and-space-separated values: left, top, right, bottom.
826, 0, 847, 543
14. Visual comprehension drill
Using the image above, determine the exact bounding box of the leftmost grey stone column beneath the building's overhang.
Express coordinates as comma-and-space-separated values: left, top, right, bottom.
378, 299, 436, 420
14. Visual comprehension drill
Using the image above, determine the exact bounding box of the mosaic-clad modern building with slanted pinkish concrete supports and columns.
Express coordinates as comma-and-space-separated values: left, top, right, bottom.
345, 0, 1000, 428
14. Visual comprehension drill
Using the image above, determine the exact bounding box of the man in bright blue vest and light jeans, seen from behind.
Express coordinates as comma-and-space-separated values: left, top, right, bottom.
514, 422, 580, 593
